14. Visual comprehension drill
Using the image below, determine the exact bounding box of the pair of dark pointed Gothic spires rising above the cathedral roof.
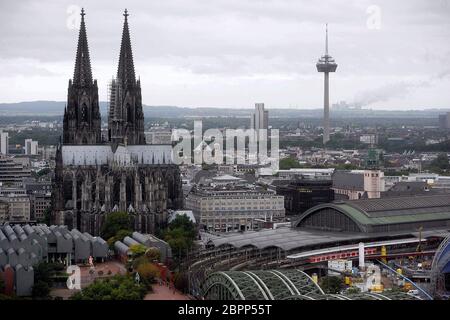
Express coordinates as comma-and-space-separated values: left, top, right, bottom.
64, 9, 145, 145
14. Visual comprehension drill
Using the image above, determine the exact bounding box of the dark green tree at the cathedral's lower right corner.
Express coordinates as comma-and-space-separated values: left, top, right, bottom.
164, 215, 197, 260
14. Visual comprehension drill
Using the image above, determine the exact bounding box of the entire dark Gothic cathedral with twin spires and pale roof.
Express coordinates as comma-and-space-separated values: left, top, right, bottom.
53, 10, 183, 235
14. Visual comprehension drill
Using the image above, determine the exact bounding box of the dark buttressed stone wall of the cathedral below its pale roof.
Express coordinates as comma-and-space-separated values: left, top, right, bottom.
55, 158, 182, 235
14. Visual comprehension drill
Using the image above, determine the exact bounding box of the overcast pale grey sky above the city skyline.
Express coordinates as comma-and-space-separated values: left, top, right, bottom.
0, 0, 450, 110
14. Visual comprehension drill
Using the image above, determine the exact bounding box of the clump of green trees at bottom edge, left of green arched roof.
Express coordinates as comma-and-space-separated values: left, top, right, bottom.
70, 275, 148, 300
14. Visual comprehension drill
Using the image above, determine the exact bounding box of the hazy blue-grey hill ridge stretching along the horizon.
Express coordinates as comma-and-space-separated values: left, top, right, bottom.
0, 101, 450, 119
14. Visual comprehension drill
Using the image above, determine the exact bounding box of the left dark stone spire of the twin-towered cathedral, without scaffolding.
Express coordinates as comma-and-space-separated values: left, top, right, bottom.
63, 9, 102, 144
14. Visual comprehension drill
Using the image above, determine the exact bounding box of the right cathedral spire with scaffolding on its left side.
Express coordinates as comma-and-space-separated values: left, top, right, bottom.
108, 9, 145, 150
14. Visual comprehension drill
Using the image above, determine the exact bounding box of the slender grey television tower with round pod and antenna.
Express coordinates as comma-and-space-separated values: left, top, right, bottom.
316, 23, 337, 144
